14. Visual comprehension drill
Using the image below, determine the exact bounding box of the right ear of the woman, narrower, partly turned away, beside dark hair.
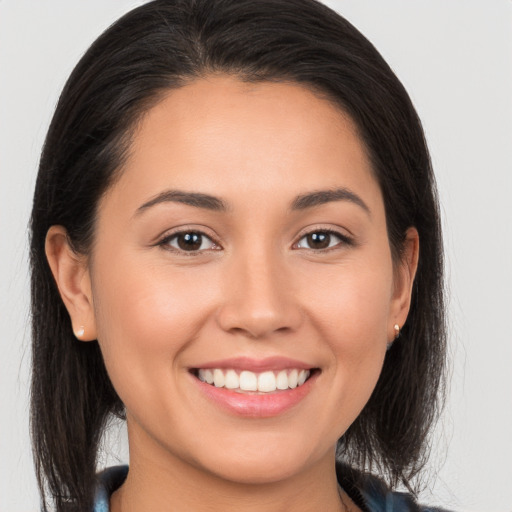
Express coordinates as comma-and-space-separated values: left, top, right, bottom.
388, 227, 420, 341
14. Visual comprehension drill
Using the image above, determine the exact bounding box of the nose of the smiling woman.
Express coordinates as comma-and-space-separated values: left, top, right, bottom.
217, 251, 303, 339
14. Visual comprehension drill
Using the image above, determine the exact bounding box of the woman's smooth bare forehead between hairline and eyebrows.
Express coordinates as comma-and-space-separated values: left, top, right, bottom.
101, 75, 376, 212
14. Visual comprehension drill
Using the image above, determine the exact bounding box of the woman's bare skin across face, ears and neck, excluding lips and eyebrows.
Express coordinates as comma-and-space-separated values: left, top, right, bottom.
47, 75, 419, 512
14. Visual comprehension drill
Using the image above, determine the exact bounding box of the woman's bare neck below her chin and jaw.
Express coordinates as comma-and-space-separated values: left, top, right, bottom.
110, 428, 359, 512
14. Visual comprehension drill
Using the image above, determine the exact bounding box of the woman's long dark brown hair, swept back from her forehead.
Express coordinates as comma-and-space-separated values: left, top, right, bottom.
31, 0, 445, 512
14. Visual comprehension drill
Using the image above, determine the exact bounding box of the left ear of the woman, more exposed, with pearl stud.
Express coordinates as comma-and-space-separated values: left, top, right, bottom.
45, 226, 97, 341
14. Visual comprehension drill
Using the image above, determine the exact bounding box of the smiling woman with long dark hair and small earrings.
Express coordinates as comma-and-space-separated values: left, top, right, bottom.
31, 0, 445, 512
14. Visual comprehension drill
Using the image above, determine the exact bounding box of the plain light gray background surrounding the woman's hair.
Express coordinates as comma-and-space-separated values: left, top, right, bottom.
0, 0, 512, 512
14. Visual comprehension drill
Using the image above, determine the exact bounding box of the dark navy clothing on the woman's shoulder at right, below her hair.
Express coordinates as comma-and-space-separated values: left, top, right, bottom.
336, 463, 448, 512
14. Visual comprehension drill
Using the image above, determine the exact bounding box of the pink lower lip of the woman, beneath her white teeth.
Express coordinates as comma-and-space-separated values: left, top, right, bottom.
192, 372, 317, 418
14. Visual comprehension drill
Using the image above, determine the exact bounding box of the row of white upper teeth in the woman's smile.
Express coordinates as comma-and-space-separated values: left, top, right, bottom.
197, 368, 311, 393
